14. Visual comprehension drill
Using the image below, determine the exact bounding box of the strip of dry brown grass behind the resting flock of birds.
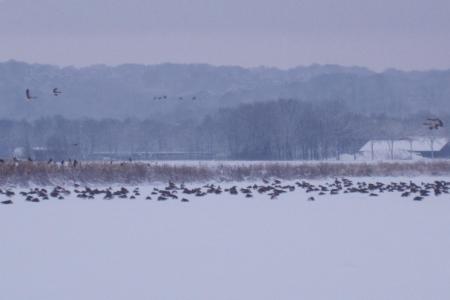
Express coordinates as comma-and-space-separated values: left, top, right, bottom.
0, 161, 450, 185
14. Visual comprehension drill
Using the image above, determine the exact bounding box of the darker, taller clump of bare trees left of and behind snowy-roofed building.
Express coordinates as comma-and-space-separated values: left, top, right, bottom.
201, 100, 442, 160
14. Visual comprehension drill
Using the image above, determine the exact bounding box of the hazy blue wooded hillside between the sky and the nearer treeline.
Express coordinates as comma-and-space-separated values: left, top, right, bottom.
0, 61, 450, 119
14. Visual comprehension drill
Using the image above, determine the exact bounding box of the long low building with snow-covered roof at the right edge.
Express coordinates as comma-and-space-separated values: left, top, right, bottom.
359, 137, 450, 160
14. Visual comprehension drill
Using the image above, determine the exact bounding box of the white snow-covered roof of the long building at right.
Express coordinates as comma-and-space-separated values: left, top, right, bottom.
360, 137, 449, 152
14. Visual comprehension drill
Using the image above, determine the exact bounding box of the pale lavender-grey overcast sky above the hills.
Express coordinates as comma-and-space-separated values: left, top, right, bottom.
0, 0, 450, 70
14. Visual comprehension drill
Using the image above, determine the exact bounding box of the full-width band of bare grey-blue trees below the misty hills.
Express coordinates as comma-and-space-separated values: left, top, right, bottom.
0, 100, 444, 160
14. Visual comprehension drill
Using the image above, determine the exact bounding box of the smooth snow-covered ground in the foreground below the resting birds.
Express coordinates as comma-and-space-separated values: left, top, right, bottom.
0, 178, 450, 300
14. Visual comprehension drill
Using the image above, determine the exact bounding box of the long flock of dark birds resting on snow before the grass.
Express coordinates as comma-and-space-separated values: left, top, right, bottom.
0, 178, 450, 204
